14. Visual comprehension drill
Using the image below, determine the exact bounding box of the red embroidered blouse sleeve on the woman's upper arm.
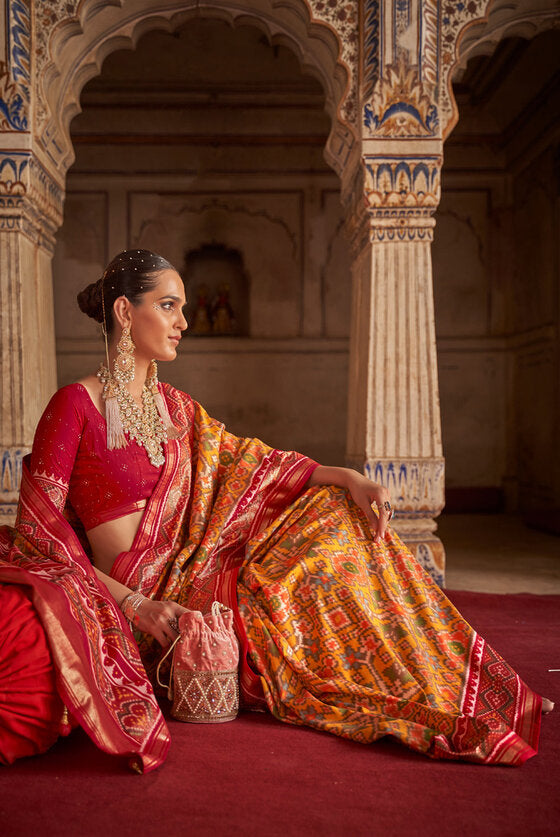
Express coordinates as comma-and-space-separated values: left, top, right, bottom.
31, 385, 84, 512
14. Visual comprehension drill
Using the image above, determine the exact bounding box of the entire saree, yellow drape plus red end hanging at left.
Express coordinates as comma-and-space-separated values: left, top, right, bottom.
0, 386, 541, 769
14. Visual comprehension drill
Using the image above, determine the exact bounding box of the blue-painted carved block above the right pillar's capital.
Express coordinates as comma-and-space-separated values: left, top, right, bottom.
361, 0, 520, 143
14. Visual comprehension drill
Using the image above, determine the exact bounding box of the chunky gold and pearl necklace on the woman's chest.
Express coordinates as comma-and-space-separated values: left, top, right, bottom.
97, 363, 167, 468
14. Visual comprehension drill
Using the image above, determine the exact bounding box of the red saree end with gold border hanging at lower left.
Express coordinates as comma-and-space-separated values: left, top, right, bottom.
0, 461, 169, 772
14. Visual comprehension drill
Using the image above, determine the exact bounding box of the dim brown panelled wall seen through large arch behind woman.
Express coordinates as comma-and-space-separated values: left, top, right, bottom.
54, 17, 350, 464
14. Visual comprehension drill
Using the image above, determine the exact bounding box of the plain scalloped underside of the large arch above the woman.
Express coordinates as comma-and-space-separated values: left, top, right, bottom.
35, 0, 357, 181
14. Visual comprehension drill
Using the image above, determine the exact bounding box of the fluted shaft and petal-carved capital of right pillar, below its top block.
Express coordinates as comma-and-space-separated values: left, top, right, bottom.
347, 149, 445, 583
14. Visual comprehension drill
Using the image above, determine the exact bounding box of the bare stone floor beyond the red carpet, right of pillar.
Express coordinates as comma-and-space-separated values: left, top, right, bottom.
438, 513, 560, 594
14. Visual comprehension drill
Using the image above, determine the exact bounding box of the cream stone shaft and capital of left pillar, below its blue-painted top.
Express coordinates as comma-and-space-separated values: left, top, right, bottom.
0, 147, 62, 523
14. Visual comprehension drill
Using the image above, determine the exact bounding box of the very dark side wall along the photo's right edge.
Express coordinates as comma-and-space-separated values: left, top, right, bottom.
509, 149, 560, 509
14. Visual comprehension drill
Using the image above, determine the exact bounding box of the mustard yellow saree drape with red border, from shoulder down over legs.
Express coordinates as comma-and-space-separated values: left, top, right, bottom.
113, 388, 541, 764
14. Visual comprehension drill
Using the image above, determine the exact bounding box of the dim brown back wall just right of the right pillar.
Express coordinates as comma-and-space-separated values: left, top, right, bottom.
433, 188, 508, 488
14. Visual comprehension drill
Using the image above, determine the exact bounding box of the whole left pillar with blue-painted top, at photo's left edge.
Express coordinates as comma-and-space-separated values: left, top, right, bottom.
0, 0, 64, 524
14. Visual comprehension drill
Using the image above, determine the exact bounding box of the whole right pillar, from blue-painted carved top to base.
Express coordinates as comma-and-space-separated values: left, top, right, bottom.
350, 0, 498, 584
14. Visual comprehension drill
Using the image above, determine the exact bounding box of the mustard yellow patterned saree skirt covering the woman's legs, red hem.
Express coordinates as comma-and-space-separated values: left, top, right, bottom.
238, 488, 540, 764
